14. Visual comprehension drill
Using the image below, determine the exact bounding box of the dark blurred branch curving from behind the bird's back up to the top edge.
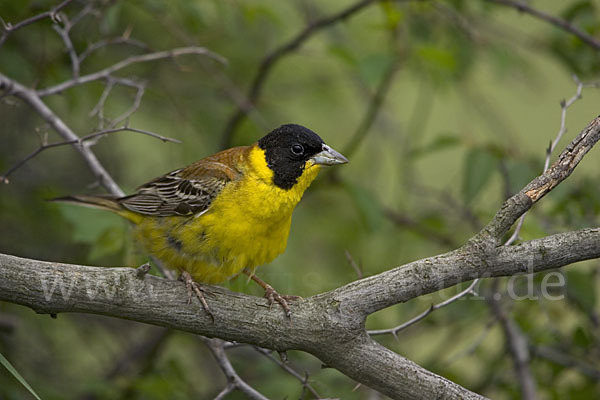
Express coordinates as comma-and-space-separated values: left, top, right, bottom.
221, 0, 376, 148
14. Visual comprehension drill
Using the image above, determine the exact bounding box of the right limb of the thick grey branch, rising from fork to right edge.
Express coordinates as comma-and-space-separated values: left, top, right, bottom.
334, 228, 600, 314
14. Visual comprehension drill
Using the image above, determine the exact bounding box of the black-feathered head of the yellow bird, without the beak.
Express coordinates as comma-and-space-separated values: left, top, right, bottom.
258, 124, 343, 189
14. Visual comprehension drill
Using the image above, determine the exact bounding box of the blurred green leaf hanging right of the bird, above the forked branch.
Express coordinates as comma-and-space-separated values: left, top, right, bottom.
463, 148, 497, 203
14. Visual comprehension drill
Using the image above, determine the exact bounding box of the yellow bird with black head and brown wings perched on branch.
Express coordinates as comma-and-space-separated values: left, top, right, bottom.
52, 124, 348, 320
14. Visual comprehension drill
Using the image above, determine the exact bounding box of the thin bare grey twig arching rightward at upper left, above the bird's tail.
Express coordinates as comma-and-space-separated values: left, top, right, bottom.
37, 46, 227, 97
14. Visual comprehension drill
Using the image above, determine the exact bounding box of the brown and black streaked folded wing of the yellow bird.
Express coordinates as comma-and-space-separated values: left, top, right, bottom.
118, 156, 241, 217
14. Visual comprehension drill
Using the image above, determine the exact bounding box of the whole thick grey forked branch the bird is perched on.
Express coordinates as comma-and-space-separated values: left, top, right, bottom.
0, 228, 600, 399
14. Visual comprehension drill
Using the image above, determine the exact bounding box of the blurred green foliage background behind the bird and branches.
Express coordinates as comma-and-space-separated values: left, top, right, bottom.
0, 0, 600, 399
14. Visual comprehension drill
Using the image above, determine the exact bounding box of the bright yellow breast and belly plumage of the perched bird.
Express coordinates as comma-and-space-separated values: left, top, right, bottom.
135, 148, 319, 284
